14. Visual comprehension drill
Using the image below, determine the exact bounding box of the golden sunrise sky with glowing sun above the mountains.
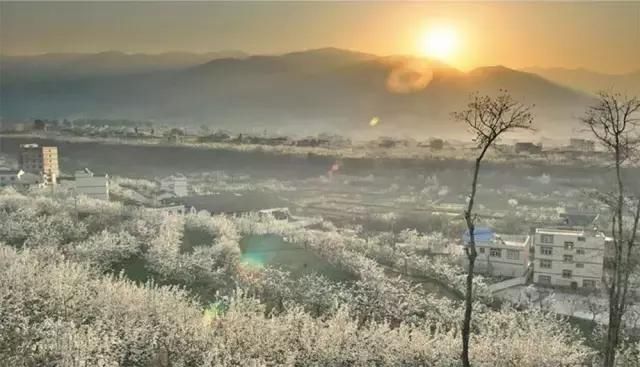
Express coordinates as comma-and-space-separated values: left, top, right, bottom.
0, 1, 640, 73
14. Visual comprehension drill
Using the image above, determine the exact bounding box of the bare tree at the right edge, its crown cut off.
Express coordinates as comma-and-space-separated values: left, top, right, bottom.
582, 92, 640, 367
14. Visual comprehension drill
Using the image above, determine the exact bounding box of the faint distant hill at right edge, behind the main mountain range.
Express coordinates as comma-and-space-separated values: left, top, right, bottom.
524, 68, 640, 96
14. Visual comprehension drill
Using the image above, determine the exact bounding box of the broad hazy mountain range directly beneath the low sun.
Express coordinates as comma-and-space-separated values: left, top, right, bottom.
0, 48, 592, 137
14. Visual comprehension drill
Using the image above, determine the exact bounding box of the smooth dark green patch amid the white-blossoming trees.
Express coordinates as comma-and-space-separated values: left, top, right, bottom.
240, 235, 355, 281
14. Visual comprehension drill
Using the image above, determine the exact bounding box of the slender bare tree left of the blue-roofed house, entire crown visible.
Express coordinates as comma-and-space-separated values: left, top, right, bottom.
453, 90, 533, 367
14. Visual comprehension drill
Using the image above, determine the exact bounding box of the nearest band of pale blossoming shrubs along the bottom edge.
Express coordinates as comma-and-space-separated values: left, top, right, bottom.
0, 246, 591, 367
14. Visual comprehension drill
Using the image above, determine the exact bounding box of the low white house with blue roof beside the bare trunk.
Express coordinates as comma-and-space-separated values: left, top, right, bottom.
463, 227, 531, 278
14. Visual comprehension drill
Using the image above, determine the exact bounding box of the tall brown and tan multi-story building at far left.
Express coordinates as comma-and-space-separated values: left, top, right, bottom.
19, 144, 60, 184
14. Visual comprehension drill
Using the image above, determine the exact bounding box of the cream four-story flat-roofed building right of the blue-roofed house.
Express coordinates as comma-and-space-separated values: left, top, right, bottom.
533, 228, 608, 288
